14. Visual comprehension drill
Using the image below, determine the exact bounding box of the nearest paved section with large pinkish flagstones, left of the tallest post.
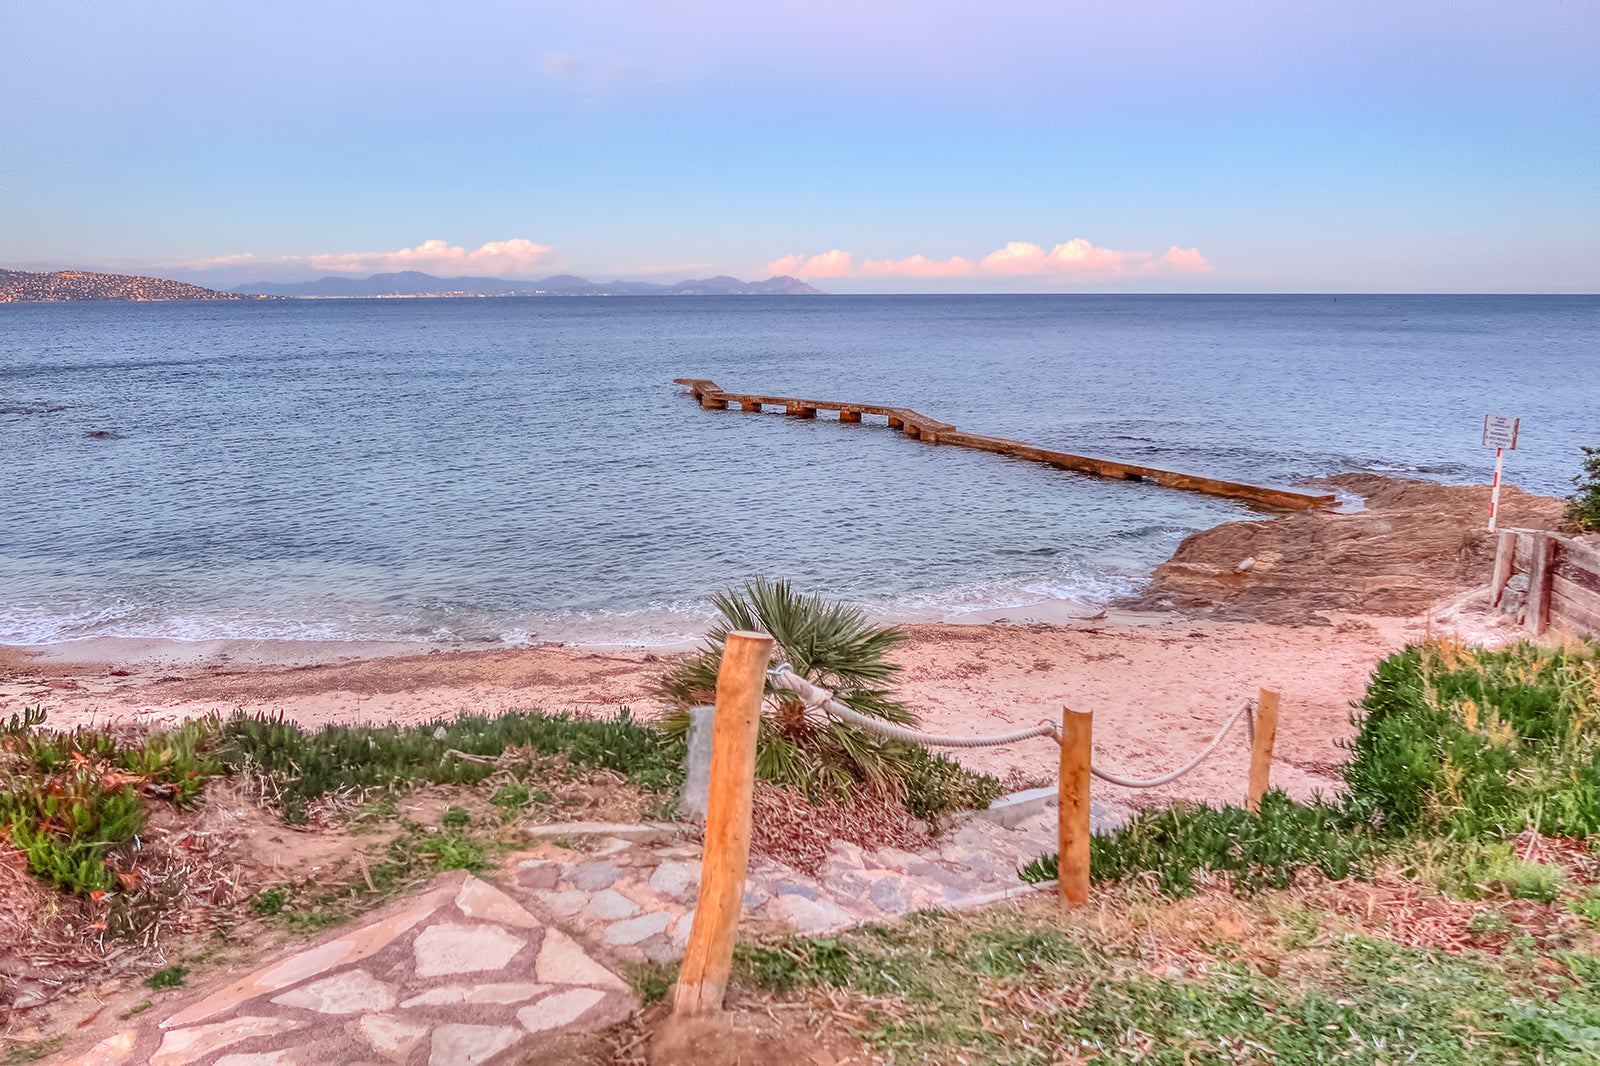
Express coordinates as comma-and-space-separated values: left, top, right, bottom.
62, 874, 637, 1066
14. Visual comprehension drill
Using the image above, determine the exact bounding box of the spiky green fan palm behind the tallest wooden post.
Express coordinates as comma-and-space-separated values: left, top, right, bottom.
659, 578, 926, 799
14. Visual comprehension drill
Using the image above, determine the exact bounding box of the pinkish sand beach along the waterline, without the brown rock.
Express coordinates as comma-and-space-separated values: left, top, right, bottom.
0, 598, 1504, 810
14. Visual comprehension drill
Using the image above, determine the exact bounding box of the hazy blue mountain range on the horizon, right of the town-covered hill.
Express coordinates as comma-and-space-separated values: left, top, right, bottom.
234, 271, 821, 299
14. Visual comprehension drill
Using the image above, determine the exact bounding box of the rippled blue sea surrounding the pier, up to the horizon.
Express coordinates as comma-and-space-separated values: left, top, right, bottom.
0, 296, 1600, 643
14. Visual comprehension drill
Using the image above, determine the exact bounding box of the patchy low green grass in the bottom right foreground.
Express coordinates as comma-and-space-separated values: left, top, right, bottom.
736, 901, 1600, 1066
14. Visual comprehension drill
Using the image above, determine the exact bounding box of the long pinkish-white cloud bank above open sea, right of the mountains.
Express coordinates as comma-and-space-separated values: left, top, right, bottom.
766, 237, 1211, 282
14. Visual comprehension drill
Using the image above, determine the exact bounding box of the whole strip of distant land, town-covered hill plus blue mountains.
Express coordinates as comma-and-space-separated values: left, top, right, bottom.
0, 271, 822, 304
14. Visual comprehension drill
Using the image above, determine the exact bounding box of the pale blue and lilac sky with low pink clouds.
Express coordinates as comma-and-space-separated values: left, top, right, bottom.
0, 0, 1600, 293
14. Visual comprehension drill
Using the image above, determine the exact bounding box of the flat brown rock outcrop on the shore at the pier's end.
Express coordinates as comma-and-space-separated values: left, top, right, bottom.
1130, 474, 1565, 624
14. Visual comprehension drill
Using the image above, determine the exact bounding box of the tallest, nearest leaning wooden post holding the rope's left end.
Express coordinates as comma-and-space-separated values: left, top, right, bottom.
672, 631, 773, 1015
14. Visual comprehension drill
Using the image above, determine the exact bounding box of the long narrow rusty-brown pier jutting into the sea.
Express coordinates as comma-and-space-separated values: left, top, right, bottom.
674, 378, 1338, 511
